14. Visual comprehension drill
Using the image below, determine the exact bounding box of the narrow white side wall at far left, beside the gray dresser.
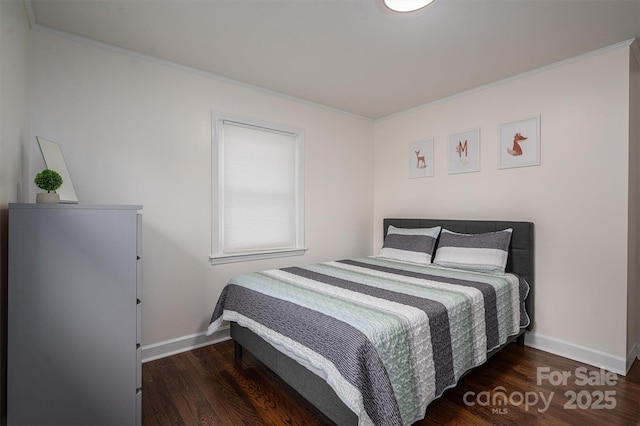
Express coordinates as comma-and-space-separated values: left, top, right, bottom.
0, 0, 30, 424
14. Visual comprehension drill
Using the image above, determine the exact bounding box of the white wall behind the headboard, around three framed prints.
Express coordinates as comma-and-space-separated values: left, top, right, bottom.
373, 44, 636, 372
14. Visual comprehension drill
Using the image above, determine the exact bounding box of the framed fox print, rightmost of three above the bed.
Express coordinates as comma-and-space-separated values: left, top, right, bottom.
498, 116, 540, 169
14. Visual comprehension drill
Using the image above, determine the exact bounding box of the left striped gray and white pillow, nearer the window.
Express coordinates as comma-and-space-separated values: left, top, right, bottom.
380, 225, 440, 265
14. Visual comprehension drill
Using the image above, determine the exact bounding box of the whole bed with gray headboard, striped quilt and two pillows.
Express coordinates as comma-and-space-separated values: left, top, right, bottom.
208, 219, 535, 425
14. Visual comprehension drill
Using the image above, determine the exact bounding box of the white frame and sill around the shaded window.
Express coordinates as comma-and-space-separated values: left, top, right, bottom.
209, 112, 307, 265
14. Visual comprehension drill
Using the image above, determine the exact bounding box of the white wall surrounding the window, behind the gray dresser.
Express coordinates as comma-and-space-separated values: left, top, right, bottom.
30, 32, 373, 357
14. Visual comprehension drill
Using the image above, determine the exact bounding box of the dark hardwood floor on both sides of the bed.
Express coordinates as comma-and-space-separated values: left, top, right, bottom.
142, 341, 640, 426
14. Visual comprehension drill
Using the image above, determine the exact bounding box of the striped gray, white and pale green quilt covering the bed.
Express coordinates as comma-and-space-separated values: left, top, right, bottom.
208, 257, 528, 425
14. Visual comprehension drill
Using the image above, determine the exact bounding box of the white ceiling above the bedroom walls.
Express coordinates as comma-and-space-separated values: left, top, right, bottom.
25, 0, 640, 119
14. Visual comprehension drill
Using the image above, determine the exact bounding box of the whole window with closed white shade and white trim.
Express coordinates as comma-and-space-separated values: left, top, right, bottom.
211, 115, 305, 264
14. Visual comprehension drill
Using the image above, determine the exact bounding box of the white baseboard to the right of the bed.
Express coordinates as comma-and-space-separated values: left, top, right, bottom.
525, 333, 633, 376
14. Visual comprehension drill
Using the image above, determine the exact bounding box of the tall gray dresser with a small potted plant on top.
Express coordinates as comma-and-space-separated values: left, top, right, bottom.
7, 204, 142, 426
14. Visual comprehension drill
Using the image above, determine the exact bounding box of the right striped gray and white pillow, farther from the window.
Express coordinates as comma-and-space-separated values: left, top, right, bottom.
434, 228, 513, 273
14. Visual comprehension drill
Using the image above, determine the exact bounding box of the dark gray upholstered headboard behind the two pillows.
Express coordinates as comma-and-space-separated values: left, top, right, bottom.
383, 218, 535, 330
